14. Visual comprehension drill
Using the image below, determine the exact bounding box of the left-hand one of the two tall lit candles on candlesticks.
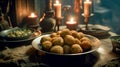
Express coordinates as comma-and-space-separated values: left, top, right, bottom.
54, 0, 61, 18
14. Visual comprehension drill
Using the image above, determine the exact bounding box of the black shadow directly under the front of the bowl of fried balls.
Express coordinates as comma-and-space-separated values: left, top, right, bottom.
29, 52, 99, 67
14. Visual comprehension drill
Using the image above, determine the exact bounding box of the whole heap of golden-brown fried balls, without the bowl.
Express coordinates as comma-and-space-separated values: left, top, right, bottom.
40, 29, 92, 54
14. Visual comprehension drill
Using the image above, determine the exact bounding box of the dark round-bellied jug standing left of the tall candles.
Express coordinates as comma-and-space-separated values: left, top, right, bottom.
40, 10, 56, 33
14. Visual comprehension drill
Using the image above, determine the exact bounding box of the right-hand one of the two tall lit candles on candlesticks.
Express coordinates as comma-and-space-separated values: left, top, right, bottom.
84, 0, 92, 17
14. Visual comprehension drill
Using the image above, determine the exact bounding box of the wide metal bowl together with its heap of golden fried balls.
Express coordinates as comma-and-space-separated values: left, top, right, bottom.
32, 29, 100, 56
